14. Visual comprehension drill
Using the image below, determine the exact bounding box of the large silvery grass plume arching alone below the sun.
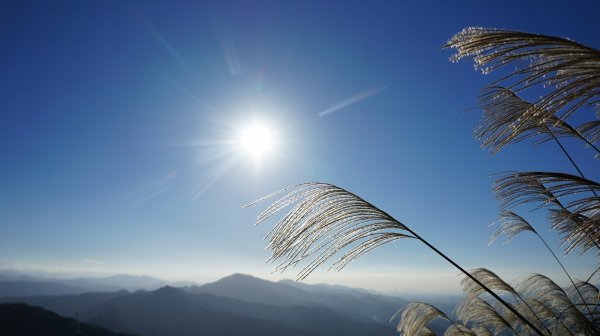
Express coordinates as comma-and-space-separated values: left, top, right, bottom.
246, 183, 415, 280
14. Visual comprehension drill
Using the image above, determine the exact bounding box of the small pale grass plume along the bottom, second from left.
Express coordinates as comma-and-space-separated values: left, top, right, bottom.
455, 296, 515, 335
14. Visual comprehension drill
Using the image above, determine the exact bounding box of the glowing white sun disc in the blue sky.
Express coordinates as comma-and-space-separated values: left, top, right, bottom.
238, 121, 277, 160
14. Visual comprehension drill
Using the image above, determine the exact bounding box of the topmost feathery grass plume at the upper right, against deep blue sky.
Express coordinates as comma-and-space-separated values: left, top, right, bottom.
444, 27, 600, 129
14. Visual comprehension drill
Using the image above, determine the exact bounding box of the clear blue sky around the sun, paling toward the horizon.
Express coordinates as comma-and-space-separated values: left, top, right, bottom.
0, 1, 600, 293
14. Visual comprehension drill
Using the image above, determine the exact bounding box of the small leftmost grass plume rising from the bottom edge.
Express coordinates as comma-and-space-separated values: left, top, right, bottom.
390, 302, 452, 335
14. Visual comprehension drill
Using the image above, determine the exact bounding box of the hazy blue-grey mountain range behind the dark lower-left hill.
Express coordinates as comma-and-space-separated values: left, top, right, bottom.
0, 274, 405, 336
